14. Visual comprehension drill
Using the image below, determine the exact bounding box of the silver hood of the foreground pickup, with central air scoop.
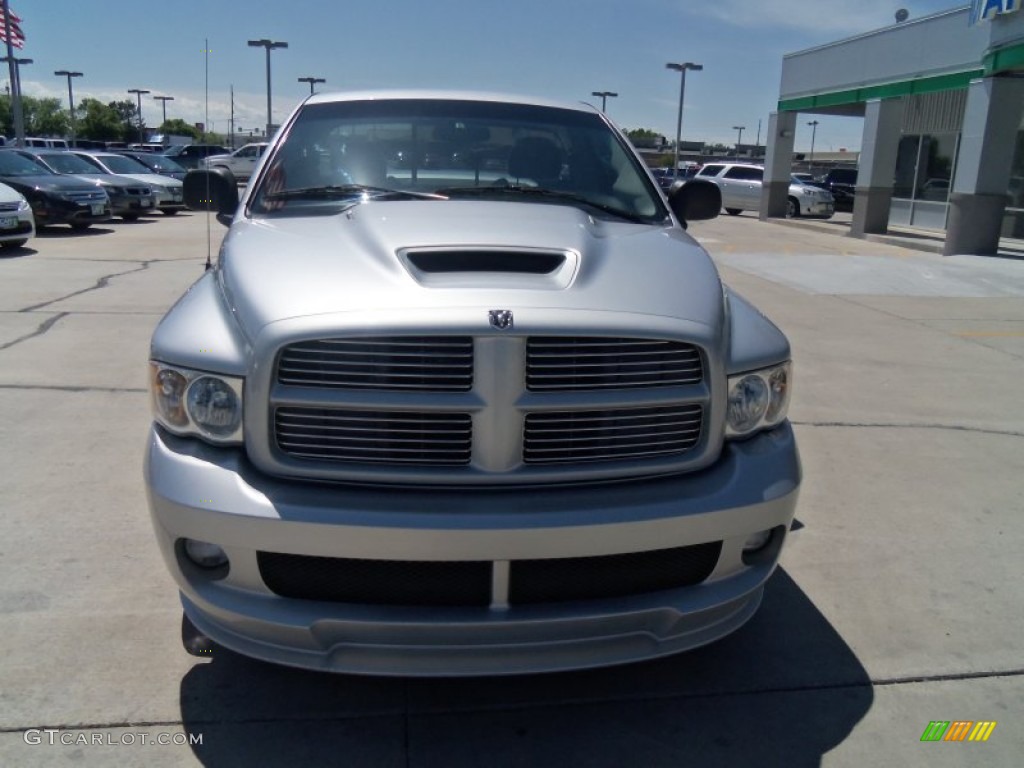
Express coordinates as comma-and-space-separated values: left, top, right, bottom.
218, 201, 722, 338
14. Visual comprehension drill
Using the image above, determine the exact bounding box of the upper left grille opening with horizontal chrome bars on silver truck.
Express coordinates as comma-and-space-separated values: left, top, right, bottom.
278, 336, 473, 392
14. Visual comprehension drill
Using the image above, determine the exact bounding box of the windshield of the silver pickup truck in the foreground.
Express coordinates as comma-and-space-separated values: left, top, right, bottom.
250, 98, 668, 222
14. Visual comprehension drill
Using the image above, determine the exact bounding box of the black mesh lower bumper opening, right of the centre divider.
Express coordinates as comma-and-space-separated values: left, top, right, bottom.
509, 542, 722, 605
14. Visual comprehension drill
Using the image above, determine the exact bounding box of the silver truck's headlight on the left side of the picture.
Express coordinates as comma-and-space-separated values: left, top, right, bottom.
150, 360, 243, 444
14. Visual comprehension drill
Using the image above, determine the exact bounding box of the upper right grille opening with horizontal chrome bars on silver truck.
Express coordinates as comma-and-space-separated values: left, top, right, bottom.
526, 336, 703, 391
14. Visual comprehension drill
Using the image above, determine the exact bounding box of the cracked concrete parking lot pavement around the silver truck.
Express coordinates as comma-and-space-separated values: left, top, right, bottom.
0, 214, 1024, 768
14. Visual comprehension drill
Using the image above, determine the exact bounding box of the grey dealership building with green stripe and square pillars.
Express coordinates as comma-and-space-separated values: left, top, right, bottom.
761, 0, 1024, 255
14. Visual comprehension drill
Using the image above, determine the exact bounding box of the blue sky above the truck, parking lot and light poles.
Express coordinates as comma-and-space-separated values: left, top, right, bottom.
9, 0, 967, 152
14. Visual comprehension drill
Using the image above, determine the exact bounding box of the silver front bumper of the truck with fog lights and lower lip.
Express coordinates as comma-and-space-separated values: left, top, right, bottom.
145, 424, 801, 675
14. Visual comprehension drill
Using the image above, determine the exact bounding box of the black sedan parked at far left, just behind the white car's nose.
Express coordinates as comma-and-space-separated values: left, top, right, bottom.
0, 148, 111, 229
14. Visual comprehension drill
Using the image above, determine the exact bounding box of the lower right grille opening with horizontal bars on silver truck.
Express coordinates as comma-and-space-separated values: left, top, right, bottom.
523, 404, 703, 464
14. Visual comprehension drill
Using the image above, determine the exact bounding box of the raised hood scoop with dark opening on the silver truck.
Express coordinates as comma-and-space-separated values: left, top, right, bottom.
398, 247, 580, 290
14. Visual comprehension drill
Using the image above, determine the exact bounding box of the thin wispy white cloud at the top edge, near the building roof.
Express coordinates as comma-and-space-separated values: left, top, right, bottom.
686, 0, 942, 37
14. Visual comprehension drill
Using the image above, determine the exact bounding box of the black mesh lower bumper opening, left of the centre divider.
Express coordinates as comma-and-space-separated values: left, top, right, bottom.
257, 552, 490, 606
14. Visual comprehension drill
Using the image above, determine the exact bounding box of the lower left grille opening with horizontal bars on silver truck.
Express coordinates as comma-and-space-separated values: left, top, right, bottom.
274, 407, 472, 466
